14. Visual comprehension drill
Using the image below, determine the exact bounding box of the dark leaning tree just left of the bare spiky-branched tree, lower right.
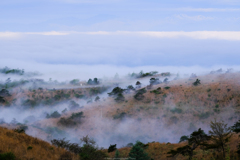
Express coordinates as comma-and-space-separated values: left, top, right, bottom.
168, 128, 209, 160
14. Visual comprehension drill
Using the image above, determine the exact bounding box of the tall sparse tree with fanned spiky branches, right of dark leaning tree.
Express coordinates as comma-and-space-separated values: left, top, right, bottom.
206, 119, 232, 158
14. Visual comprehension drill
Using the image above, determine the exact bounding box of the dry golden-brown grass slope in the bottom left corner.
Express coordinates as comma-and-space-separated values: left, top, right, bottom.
0, 127, 79, 160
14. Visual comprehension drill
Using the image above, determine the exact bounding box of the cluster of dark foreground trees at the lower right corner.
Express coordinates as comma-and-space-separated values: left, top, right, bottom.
168, 119, 240, 160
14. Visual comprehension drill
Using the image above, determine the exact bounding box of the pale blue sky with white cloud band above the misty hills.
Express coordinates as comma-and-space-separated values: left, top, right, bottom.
0, 0, 240, 79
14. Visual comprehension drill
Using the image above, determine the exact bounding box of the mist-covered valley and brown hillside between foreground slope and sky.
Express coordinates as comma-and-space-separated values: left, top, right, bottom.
0, 67, 240, 151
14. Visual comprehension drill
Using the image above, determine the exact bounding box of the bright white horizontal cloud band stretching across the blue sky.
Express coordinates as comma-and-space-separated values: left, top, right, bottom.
0, 30, 240, 41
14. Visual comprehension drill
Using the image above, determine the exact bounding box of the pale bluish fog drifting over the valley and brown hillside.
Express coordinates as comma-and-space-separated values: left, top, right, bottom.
0, 66, 239, 148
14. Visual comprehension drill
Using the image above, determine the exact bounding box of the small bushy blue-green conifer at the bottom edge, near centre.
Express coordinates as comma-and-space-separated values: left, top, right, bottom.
129, 141, 150, 160
